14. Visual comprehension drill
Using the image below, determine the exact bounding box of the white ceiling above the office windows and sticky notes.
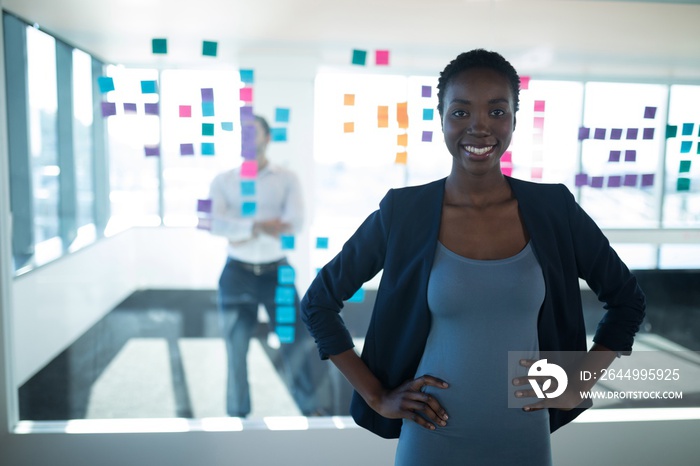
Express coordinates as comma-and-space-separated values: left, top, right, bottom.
0, 0, 700, 82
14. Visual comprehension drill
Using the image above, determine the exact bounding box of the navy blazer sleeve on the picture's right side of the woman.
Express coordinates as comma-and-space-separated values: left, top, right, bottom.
563, 187, 646, 354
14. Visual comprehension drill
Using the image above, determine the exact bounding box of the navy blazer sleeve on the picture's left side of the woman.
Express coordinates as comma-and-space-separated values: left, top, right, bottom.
301, 191, 393, 359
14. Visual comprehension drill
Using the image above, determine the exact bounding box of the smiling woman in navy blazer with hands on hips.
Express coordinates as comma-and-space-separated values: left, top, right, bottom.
302, 49, 644, 466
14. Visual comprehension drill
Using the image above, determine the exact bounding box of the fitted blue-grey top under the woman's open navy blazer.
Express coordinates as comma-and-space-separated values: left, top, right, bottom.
395, 243, 551, 466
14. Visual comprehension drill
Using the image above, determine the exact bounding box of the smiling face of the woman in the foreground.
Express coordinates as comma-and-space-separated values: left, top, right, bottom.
442, 68, 515, 175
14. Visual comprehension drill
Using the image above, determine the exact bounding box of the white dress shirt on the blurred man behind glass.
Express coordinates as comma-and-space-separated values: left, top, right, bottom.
209, 163, 304, 264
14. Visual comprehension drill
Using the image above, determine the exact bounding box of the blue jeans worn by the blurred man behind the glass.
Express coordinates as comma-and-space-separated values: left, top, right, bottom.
218, 258, 331, 417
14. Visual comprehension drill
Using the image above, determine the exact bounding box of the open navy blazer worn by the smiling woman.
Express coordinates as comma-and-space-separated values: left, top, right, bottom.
301, 177, 645, 438
